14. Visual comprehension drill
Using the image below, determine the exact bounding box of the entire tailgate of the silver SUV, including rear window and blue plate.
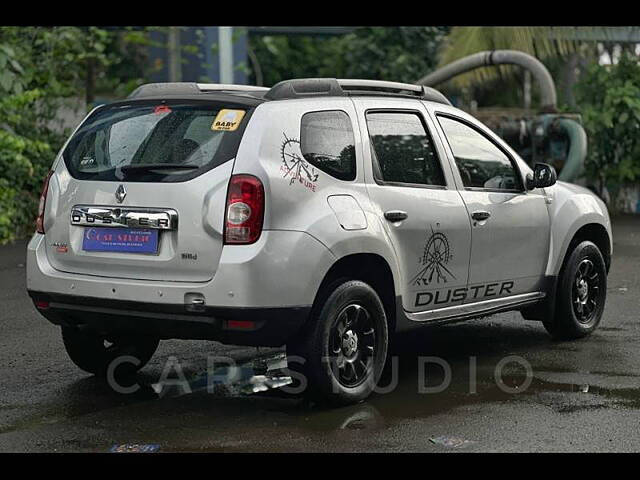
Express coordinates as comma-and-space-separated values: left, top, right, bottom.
39, 101, 255, 282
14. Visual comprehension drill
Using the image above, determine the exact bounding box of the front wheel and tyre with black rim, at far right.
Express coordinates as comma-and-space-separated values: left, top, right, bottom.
543, 241, 607, 340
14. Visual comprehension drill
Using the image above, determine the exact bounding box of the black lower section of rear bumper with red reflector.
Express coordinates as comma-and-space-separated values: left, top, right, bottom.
29, 290, 311, 347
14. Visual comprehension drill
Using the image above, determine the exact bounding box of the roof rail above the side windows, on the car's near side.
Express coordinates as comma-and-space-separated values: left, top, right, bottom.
264, 78, 451, 105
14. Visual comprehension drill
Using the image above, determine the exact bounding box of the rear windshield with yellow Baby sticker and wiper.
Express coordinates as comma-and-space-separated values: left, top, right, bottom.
63, 101, 250, 182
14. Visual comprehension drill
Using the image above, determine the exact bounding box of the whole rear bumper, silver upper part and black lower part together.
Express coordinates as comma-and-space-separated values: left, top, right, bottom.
27, 231, 335, 346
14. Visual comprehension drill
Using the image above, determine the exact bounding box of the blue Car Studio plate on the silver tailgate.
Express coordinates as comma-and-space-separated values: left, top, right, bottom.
82, 227, 158, 255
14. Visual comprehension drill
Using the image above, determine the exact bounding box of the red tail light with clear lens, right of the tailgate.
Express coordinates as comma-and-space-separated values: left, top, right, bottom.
224, 175, 264, 245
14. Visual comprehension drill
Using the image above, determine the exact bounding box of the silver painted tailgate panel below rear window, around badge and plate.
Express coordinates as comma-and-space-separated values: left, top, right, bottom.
45, 161, 233, 282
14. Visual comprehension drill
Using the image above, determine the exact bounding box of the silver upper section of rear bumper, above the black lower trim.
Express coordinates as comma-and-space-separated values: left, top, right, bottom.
27, 230, 335, 308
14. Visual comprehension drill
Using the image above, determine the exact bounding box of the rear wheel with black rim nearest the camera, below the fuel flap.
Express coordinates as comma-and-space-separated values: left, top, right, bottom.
287, 280, 388, 405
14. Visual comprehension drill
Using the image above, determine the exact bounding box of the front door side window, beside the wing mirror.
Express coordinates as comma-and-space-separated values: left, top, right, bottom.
438, 115, 521, 191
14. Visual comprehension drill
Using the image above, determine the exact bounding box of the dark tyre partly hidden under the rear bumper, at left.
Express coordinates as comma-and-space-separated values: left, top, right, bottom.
62, 327, 159, 377
